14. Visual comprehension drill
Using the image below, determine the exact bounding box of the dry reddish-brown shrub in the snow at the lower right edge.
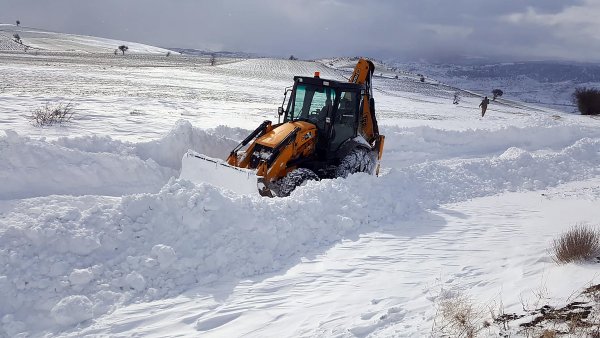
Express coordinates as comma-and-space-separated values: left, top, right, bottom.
552, 224, 600, 264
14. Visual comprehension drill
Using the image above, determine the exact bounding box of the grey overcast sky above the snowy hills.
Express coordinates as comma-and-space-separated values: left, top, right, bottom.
0, 0, 600, 62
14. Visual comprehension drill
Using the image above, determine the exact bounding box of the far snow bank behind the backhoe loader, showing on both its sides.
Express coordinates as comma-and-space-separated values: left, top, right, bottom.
0, 120, 600, 200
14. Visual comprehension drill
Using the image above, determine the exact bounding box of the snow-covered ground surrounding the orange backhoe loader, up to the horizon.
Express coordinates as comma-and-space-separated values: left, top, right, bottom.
0, 30, 600, 337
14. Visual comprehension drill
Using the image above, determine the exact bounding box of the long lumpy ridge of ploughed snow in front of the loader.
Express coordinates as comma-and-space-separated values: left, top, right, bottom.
0, 129, 600, 335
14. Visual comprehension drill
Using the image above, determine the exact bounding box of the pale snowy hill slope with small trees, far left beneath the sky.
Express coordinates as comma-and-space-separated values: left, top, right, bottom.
0, 24, 169, 55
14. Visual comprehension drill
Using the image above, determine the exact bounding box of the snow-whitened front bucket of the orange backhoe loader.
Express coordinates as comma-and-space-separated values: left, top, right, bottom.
179, 150, 259, 195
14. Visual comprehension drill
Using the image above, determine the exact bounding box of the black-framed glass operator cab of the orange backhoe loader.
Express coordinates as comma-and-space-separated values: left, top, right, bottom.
283, 76, 365, 158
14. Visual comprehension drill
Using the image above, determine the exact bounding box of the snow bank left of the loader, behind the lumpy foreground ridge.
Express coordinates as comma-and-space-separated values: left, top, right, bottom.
0, 121, 237, 199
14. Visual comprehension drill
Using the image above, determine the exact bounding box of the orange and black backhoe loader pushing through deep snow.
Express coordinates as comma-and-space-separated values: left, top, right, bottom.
180, 59, 384, 197
